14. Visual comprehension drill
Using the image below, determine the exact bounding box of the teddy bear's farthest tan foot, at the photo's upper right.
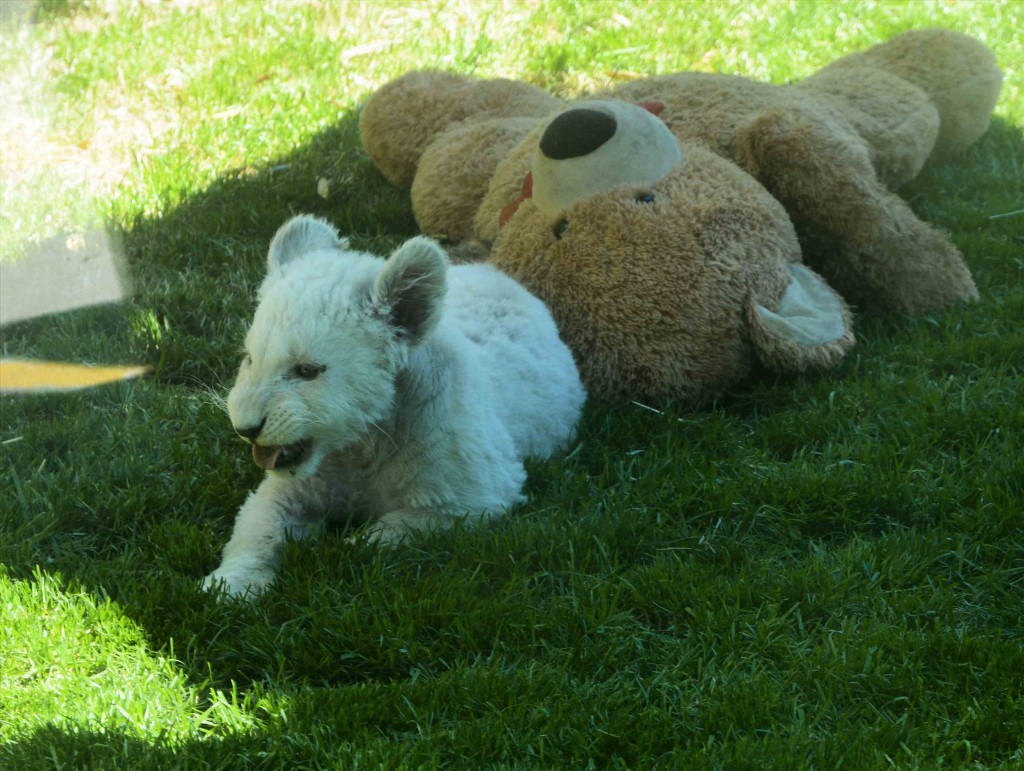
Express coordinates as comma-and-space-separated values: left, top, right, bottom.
806, 29, 1002, 160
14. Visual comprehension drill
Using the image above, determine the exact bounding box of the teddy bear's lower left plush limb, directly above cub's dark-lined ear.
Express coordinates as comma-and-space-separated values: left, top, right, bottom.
412, 118, 537, 241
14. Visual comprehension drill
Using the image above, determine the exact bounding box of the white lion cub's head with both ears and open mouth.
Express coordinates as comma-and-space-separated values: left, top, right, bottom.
227, 216, 447, 476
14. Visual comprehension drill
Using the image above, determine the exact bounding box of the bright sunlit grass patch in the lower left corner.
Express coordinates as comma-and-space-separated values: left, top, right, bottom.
0, 566, 273, 745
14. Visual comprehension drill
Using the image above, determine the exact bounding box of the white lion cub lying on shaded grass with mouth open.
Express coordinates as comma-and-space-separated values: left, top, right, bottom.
204, 216, 585, 595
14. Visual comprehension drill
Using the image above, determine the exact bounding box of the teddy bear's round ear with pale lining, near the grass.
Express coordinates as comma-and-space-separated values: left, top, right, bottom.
746, 263, 854, 372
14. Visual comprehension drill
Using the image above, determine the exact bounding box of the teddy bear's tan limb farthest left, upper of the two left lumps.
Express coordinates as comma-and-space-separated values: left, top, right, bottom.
359, 71, 561, 187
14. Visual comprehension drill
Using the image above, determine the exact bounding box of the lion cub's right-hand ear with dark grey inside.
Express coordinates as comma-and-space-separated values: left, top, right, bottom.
373, 235, 447, 341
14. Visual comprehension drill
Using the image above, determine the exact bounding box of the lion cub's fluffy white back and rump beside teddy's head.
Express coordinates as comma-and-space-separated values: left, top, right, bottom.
446, 264, 586, 458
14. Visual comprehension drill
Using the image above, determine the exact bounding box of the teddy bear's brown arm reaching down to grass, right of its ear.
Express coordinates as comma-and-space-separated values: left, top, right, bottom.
733, 109, 978, 313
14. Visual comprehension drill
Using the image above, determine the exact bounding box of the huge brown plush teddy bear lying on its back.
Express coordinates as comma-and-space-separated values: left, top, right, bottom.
359, 30, 1001, 404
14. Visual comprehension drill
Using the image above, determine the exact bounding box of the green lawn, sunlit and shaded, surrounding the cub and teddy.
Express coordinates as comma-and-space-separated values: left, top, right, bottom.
0, 0, 1024, 769
